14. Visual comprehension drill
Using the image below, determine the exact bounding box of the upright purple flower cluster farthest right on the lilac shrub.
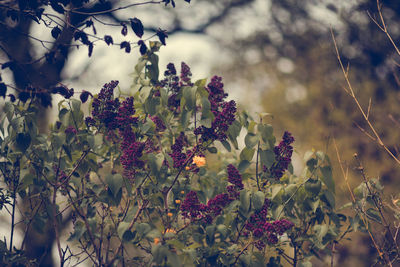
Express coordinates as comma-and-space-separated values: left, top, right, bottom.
264, 131, 294, 179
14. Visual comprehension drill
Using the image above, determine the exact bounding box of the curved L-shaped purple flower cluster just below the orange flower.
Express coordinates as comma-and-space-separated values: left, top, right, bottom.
181, 165, 243, 224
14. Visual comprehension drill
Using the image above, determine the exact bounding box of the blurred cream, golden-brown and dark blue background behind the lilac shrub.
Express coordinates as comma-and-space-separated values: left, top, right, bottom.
1, 0, 400, 266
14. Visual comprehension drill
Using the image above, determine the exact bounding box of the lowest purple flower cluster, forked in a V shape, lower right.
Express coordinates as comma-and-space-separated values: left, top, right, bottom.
244, 199, 294, 250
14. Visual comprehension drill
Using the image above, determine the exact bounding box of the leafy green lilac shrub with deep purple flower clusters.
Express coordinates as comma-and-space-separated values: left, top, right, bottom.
0, 42, 351, 266
